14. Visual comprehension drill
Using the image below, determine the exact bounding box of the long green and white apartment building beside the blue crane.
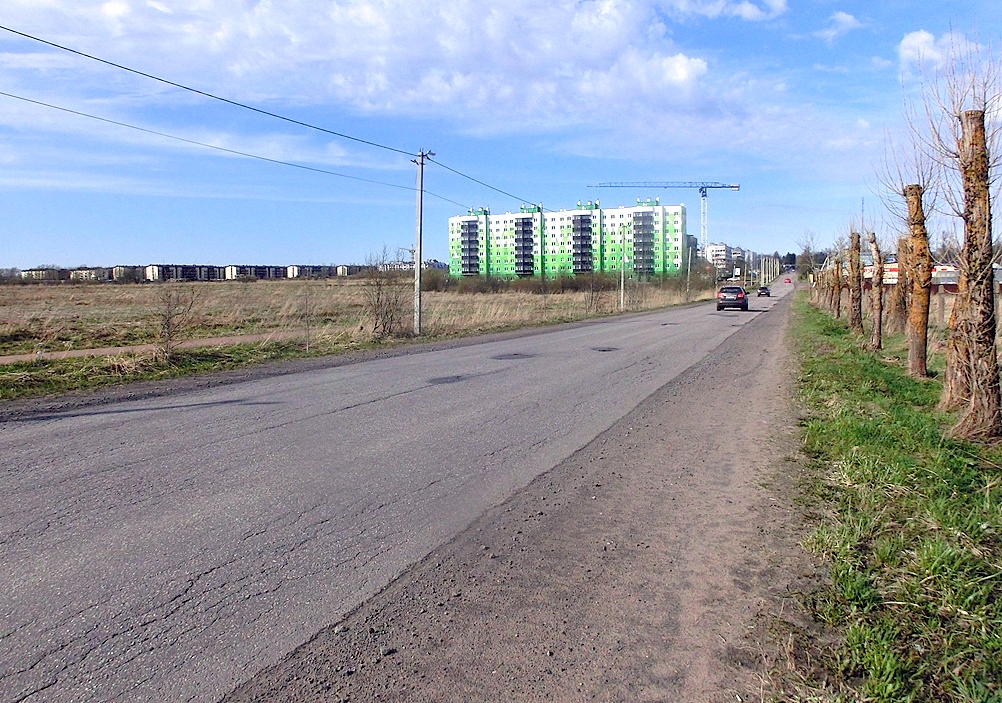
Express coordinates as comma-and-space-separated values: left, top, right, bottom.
449, 199, 694, 278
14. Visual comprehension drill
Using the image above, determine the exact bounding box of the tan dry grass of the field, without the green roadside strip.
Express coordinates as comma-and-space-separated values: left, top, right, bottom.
0, 280, 713, 356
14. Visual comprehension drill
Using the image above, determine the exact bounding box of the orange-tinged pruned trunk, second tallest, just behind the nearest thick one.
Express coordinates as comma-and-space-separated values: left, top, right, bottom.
904, 184, 933, 378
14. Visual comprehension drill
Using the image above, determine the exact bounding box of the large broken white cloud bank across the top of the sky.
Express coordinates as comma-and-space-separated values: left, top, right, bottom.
0, 0, 833, 174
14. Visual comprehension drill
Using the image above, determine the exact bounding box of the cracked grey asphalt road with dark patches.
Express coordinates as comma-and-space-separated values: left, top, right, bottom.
0, 284, 793, 701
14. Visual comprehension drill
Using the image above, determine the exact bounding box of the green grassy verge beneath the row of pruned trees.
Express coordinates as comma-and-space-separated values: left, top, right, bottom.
793, 298, 1002, 702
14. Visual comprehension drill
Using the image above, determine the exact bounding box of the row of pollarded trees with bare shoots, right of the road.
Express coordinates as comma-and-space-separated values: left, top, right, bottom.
798, 40, 1002, 440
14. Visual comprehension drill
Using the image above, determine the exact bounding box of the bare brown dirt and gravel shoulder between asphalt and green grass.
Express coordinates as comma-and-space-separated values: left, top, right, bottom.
225, 300, 814, 703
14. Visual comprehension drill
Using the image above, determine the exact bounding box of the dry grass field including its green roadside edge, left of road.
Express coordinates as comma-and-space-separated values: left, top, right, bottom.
0, 279, 712, 400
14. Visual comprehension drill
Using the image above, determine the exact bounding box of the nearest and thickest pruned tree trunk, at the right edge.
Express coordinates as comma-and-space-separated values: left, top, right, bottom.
951, 110, 1002, 439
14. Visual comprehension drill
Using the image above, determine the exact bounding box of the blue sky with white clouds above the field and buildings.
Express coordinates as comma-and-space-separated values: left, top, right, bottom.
0, 0, 1002, 268
